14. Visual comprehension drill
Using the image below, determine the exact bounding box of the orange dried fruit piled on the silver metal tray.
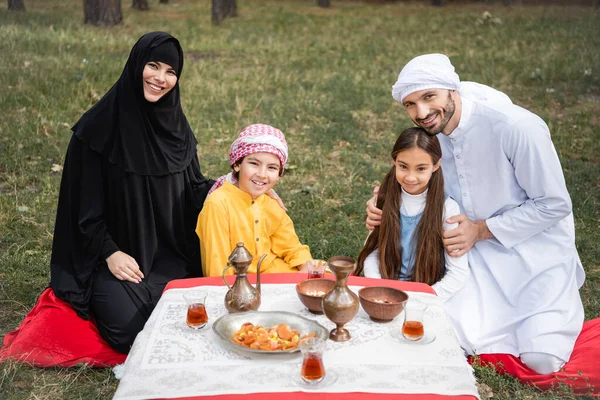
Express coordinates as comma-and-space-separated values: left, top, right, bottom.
232, 322, 315, 351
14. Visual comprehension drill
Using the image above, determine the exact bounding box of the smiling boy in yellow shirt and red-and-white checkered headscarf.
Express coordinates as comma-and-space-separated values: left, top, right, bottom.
196, 124, 312, 276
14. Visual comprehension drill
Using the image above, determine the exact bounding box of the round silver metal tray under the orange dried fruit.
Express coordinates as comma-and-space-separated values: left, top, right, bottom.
213, 311, 329, 354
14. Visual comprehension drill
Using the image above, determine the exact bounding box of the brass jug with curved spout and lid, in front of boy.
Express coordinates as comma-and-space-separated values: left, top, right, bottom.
222, 242, 267, 313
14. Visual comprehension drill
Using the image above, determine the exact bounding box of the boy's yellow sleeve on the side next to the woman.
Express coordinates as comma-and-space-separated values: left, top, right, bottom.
196, 202, 231, 276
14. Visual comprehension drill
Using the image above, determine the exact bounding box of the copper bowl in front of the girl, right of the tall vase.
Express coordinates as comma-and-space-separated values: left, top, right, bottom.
358, 286, 408, 322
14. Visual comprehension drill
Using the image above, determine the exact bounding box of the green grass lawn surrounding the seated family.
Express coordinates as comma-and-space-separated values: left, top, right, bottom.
0, 0, 600, 399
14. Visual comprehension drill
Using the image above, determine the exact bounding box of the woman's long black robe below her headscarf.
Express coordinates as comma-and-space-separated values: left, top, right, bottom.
51, 136, 213, 353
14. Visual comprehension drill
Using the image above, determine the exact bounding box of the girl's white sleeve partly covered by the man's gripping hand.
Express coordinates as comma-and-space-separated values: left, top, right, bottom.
433, 198, 470, 302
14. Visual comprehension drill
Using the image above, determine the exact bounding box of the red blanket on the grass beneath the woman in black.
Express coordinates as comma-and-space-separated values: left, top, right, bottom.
0, 288, 127, 367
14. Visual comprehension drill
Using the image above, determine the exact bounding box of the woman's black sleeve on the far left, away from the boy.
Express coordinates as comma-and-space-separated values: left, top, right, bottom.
50, 136, 119, 319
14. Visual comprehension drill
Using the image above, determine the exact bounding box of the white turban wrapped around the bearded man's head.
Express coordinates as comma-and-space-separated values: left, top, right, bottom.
392, 54, 460, 103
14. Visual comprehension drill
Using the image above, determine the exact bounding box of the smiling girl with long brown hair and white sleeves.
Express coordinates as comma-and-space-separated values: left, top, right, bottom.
356, 128, 469, 301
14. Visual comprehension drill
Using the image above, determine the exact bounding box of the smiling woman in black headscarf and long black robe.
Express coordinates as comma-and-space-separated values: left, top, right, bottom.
50, 32, 214, 353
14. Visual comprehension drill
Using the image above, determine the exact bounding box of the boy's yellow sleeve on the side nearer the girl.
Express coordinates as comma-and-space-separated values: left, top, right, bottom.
271, 213, 312, 272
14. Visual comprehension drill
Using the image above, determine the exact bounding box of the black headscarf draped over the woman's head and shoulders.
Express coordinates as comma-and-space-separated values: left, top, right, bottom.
72, 32, 196, 176
